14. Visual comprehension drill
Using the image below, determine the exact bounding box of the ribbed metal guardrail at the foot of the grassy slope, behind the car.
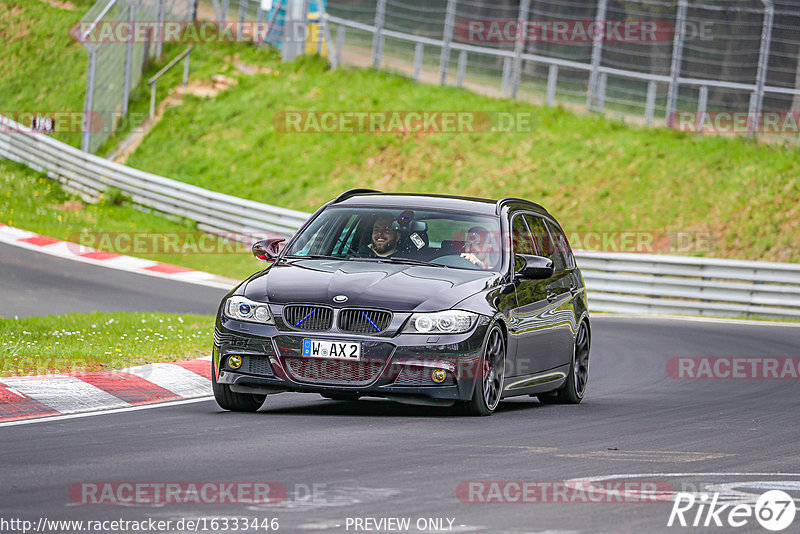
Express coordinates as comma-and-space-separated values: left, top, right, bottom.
0, 117, 800, 319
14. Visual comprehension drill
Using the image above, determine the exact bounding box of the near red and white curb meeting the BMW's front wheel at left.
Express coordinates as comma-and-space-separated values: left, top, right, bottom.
0, 356, 212, 421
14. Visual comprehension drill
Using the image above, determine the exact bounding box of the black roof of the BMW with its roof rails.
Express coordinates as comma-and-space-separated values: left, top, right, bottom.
332, 190, 547, 215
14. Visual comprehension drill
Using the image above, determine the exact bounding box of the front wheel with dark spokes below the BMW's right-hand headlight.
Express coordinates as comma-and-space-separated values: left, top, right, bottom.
456, 325, 506, 416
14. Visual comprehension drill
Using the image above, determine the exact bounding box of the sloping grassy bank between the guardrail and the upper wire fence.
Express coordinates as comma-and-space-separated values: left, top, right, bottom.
119, 53, 800, 261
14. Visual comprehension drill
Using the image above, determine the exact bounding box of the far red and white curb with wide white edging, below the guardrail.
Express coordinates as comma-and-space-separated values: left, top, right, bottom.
0, 224, 238, 289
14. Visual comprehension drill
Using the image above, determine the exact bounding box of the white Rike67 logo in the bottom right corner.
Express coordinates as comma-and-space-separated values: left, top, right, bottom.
667, 490, 796, 532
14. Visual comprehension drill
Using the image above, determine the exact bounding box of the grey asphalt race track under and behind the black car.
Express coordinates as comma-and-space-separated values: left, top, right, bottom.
0, 246, 800, 534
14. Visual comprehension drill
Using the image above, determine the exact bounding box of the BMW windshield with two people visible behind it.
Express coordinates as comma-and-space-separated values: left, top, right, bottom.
286, 207, 502, 270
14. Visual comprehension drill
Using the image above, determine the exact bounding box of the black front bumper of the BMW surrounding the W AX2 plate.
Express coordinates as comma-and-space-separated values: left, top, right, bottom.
213, 316, 490, 406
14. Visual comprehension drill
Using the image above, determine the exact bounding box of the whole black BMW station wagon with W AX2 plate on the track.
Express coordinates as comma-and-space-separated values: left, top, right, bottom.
212, 189, 591, 415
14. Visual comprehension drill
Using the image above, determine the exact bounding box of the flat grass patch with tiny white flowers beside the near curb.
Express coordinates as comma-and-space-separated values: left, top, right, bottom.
0, 312, 214, 376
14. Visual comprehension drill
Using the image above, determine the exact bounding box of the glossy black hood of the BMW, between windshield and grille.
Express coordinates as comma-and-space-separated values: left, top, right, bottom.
244, 259, 500, 311
